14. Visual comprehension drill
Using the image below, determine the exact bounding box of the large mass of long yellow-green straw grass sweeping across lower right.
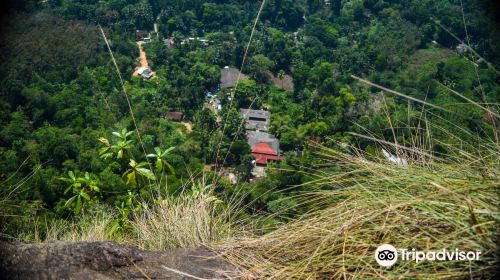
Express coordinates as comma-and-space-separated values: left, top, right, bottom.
226, 142, 500, 279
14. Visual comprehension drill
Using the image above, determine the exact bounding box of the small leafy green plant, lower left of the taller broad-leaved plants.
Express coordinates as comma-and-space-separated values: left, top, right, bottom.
60, 171, 100, 214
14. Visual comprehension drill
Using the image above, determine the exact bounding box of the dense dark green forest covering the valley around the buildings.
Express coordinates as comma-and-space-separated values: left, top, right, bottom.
0, 0, 500, 264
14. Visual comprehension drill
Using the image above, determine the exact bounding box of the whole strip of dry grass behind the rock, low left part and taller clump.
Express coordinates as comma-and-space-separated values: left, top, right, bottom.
37, 186, 242, 250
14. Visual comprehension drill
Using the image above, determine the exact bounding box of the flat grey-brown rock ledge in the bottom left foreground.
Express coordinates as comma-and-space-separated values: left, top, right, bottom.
0, 241, 237, 280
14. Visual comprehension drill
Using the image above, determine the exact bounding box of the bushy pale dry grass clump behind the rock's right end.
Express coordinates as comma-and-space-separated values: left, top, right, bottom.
132, 190, 243, 250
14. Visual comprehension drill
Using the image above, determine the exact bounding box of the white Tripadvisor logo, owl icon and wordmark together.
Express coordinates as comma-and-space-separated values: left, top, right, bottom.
374, 244, 481, 267
